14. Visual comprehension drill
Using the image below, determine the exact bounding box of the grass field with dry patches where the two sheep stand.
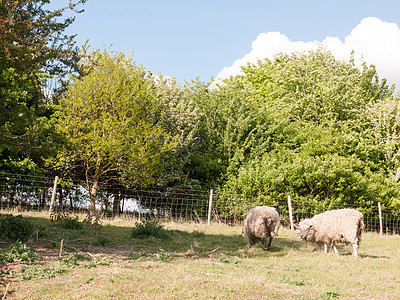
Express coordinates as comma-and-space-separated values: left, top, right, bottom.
0, 214, 400, 299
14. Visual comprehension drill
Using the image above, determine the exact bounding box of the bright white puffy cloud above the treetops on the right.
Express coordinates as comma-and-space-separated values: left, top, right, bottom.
216, 17, 400, 89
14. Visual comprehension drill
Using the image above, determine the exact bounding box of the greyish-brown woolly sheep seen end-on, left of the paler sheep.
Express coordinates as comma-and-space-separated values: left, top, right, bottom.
243, 206, 280, 251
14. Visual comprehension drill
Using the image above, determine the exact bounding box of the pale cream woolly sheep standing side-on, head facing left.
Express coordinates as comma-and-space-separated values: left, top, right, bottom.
296, 209, 364, 256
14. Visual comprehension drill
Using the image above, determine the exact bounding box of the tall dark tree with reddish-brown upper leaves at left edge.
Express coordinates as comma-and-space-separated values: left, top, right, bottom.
0, 0, 85, 172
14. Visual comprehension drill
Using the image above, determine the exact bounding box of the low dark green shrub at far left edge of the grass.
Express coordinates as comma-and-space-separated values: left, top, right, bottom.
0, 215, 34, 243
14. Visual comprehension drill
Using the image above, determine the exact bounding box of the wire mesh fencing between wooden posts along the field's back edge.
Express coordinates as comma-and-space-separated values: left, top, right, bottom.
0, 174, 400, 234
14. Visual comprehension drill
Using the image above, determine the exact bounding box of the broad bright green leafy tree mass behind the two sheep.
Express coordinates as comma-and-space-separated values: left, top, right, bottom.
208, 49, 399, 213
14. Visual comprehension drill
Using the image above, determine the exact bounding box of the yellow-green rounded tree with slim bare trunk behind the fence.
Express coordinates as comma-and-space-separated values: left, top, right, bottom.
52, 51, 175, 212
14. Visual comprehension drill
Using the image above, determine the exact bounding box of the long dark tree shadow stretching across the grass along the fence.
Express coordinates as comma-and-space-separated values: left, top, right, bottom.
0, 217, 340, 259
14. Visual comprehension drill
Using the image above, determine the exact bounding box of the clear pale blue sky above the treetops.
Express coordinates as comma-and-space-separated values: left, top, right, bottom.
52, 0, 400, 85
